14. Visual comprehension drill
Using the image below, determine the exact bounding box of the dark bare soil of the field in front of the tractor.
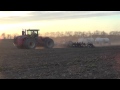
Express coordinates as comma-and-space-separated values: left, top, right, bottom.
0, 40, 120, 79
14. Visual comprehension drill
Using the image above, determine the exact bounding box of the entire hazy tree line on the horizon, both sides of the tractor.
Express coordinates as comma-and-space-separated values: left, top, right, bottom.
1, 30, 120, 39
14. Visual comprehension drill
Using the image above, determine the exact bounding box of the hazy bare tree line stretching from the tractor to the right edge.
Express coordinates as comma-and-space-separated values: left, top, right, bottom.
45, 30, 120, 37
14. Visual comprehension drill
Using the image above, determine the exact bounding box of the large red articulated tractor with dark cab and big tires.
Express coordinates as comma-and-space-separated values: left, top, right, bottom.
13, 29, 54, 49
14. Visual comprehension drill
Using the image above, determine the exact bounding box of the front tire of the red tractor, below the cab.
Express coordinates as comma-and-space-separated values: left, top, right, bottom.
24, 39, 36, 49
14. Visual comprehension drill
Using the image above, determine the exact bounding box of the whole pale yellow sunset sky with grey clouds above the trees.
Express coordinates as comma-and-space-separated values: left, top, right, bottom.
0, 11, 120, 34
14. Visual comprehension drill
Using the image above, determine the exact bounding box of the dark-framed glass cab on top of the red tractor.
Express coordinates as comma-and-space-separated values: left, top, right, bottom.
22, 29, 39, 37
